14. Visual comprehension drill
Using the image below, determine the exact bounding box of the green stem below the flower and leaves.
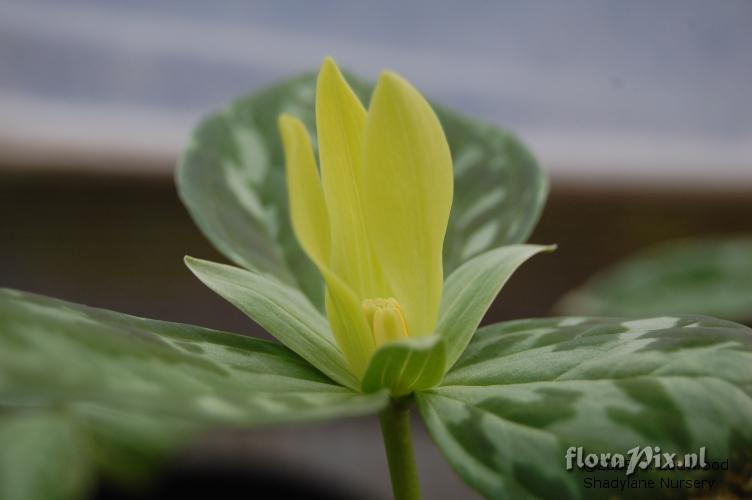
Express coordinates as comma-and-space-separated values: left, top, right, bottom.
379, 398, 420, 500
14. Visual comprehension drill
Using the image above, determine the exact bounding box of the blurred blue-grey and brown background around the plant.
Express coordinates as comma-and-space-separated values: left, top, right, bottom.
0, 0, 752, 498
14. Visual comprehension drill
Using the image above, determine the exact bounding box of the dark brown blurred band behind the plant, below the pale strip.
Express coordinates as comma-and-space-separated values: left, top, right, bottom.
0, 171, 752, 335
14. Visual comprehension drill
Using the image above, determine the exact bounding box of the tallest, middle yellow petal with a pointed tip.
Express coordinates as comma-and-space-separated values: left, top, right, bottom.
316, 58, 386, 297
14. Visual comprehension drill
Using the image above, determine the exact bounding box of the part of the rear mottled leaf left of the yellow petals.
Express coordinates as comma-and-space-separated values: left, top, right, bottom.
176, 74, 323, 306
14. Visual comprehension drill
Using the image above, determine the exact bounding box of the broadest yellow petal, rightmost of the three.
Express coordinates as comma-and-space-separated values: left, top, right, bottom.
361, 72, 453, 336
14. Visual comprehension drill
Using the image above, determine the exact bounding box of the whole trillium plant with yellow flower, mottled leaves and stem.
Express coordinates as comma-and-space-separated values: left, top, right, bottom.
0, 46, 752, 500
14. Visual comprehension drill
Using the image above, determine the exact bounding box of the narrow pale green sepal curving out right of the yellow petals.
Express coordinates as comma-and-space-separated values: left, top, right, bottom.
436, 245, 554, 368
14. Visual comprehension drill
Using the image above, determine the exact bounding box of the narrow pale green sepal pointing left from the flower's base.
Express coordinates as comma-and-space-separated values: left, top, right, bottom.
186, 257, 358, 388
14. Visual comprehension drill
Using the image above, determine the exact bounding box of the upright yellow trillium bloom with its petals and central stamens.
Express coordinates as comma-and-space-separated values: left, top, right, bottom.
279, 58, 453, 378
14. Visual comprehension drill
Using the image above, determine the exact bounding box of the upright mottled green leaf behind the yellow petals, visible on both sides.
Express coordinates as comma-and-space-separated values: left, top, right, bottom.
177, 74, 547, 308
